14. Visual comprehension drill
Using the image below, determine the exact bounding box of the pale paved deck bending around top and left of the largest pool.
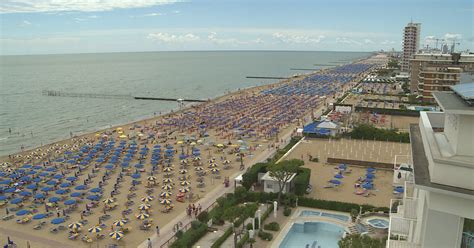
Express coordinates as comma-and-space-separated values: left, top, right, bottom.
269, 207, 351, 248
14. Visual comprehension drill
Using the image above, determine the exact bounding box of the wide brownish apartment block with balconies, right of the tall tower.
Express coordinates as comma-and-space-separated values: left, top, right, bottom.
410, 53, 474, 101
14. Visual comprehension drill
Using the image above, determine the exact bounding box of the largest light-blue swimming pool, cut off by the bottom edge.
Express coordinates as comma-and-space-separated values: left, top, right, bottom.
279, 222, 344, 248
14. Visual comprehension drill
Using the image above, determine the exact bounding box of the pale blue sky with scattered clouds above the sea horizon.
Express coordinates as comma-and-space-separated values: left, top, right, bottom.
0, 0, 474, 55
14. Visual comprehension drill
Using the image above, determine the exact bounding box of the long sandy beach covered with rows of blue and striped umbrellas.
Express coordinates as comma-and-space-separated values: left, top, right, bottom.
0, 59, 376, 247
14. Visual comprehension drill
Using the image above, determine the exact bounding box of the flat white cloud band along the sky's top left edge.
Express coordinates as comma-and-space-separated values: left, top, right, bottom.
0, 0, 178, 13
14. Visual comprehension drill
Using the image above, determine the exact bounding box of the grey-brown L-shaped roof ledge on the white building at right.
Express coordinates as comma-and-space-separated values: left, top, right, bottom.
410, 124, 474, 199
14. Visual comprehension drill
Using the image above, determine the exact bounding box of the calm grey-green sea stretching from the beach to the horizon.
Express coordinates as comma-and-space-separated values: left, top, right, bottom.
0, 51, 371, 155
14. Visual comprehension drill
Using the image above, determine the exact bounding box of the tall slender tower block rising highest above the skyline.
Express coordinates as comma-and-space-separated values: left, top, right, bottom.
401, 22, 421, 72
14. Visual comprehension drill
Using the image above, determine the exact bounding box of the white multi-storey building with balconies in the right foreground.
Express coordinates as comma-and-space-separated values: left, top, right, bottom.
387, 83, 474, 248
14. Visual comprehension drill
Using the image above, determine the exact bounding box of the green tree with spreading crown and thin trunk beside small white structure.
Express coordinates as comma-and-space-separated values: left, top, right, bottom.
268, 159, 298, 202
